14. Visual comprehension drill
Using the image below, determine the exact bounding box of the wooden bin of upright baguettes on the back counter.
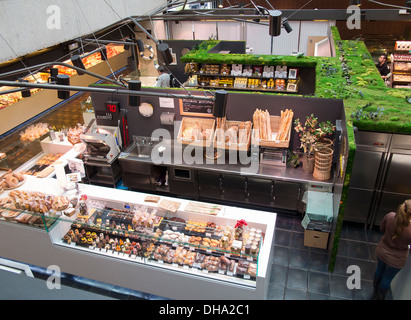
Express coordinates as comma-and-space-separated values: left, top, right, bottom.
252, 109, 294, 148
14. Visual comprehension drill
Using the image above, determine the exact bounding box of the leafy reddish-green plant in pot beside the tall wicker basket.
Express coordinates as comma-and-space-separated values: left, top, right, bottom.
294, 114, 335, 173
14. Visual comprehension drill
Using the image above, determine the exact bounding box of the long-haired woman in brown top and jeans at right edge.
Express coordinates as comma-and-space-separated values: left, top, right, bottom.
371, 199, 411, 300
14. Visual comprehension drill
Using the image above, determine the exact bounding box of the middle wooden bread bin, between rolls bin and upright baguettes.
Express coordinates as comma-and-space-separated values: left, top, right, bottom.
214, 120, 252, 151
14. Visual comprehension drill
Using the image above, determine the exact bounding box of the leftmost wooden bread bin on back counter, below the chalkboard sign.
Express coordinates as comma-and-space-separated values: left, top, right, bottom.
177, 117, 215, 147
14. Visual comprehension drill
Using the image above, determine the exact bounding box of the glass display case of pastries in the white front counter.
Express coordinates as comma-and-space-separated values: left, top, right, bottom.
43, 196, 266, 287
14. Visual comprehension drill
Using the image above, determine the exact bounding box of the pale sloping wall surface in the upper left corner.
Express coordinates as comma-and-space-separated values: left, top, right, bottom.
0, 0, 167, 62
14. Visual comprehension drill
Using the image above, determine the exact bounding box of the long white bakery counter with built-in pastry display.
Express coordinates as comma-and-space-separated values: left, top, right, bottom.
0, 176, 276, 299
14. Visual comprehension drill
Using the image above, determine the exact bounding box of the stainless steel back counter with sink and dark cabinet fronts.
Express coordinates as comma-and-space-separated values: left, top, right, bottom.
119, 140, 334, 212
